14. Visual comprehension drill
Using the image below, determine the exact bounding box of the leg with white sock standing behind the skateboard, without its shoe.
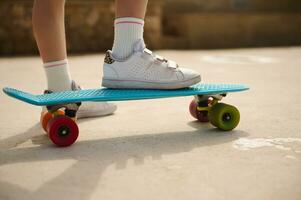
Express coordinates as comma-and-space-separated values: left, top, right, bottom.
32, 0, 71, 91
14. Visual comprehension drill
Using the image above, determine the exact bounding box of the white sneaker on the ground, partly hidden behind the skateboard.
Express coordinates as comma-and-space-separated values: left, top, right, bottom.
41, 81, 117, 119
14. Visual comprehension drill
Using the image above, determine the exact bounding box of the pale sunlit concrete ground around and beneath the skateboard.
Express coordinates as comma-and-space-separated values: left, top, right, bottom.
0, 47, 301, 200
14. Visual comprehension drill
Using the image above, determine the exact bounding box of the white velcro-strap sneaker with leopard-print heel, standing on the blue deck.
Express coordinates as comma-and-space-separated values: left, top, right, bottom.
102, 40, 201, 89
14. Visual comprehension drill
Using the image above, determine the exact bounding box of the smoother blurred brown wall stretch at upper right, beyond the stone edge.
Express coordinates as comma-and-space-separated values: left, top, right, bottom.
163, 0, 301, 49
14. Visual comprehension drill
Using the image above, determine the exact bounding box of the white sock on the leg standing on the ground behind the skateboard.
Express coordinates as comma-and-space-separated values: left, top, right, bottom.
44, 59, 72, 92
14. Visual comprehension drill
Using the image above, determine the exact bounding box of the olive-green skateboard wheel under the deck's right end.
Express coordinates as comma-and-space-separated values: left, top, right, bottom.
209, 103, 240, 131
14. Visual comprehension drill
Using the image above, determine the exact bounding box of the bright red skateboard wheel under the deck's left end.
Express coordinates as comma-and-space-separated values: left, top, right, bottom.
47, 116, 79, 147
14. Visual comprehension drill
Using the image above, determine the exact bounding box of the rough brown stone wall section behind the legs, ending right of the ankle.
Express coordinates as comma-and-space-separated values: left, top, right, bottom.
0, 0, 162, 55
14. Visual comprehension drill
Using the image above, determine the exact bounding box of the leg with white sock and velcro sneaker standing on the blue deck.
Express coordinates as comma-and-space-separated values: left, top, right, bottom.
102, 0, 201, 89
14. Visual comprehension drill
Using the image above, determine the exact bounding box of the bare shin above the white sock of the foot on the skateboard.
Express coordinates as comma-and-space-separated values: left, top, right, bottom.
115, 0, 148, 19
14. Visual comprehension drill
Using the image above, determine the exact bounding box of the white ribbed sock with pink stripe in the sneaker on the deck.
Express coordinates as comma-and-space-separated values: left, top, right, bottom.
112, 17, 144, 60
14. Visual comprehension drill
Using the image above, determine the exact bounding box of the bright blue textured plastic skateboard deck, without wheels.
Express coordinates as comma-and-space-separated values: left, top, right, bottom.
3, 83, 249, 106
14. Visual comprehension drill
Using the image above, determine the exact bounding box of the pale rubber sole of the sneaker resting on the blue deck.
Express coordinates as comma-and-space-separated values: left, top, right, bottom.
102, 76, 201, 90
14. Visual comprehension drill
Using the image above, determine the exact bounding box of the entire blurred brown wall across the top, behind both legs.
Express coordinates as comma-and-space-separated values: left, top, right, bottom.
0, 0, 301, 56
